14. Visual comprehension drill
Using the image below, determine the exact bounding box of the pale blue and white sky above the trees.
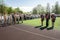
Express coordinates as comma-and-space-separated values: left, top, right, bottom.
4, 0, 60, 12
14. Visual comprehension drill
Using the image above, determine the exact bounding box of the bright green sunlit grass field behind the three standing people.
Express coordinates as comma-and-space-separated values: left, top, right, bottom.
23, 17, 60, 30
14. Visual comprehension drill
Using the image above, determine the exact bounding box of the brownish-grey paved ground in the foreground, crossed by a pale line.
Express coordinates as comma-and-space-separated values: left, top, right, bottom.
0, 24, 60, 40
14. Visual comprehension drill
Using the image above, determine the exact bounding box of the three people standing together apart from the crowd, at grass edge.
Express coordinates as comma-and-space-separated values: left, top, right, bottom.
40, 13, 56, 29
